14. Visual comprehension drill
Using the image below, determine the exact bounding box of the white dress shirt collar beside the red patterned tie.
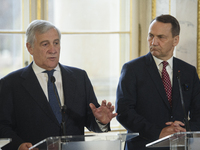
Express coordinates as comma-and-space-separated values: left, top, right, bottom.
153, 56, 173, 85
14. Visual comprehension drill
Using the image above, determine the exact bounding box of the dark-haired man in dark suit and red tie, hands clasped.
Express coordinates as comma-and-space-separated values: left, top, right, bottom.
115, 15, 200, 150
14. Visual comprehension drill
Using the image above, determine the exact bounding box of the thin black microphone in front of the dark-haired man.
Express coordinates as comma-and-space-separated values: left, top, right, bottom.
177, 70, 191, 131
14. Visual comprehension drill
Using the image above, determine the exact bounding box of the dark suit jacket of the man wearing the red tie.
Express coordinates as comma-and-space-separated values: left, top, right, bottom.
116, 53, 200, 150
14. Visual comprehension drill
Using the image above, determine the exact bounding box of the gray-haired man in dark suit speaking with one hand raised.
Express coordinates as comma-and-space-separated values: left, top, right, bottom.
0, 20, 117, 150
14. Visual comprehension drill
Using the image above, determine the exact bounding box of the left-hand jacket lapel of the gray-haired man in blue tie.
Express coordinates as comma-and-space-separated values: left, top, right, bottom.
21, 63, 59, 125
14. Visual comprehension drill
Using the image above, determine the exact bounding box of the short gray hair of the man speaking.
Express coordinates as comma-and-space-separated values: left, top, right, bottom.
26, 20, 61, 47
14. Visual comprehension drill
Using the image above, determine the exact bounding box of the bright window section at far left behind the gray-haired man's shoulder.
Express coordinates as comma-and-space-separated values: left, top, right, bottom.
0, 0, 24, 77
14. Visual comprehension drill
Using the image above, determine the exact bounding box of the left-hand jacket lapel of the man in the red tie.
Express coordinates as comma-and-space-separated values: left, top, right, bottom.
145, 52, 170, 109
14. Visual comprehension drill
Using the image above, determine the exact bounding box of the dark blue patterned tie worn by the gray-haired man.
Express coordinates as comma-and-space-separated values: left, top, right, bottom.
44, 69, 62, 124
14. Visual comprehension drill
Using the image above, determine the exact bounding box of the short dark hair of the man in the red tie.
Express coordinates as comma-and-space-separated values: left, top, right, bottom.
151, 15, 180, 37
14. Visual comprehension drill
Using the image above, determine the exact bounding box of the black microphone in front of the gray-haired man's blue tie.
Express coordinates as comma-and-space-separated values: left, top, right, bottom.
51, 76, 67, 136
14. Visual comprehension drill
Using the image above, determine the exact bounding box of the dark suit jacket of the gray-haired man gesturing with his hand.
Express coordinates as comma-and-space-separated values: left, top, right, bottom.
0, 64, 107, 150
